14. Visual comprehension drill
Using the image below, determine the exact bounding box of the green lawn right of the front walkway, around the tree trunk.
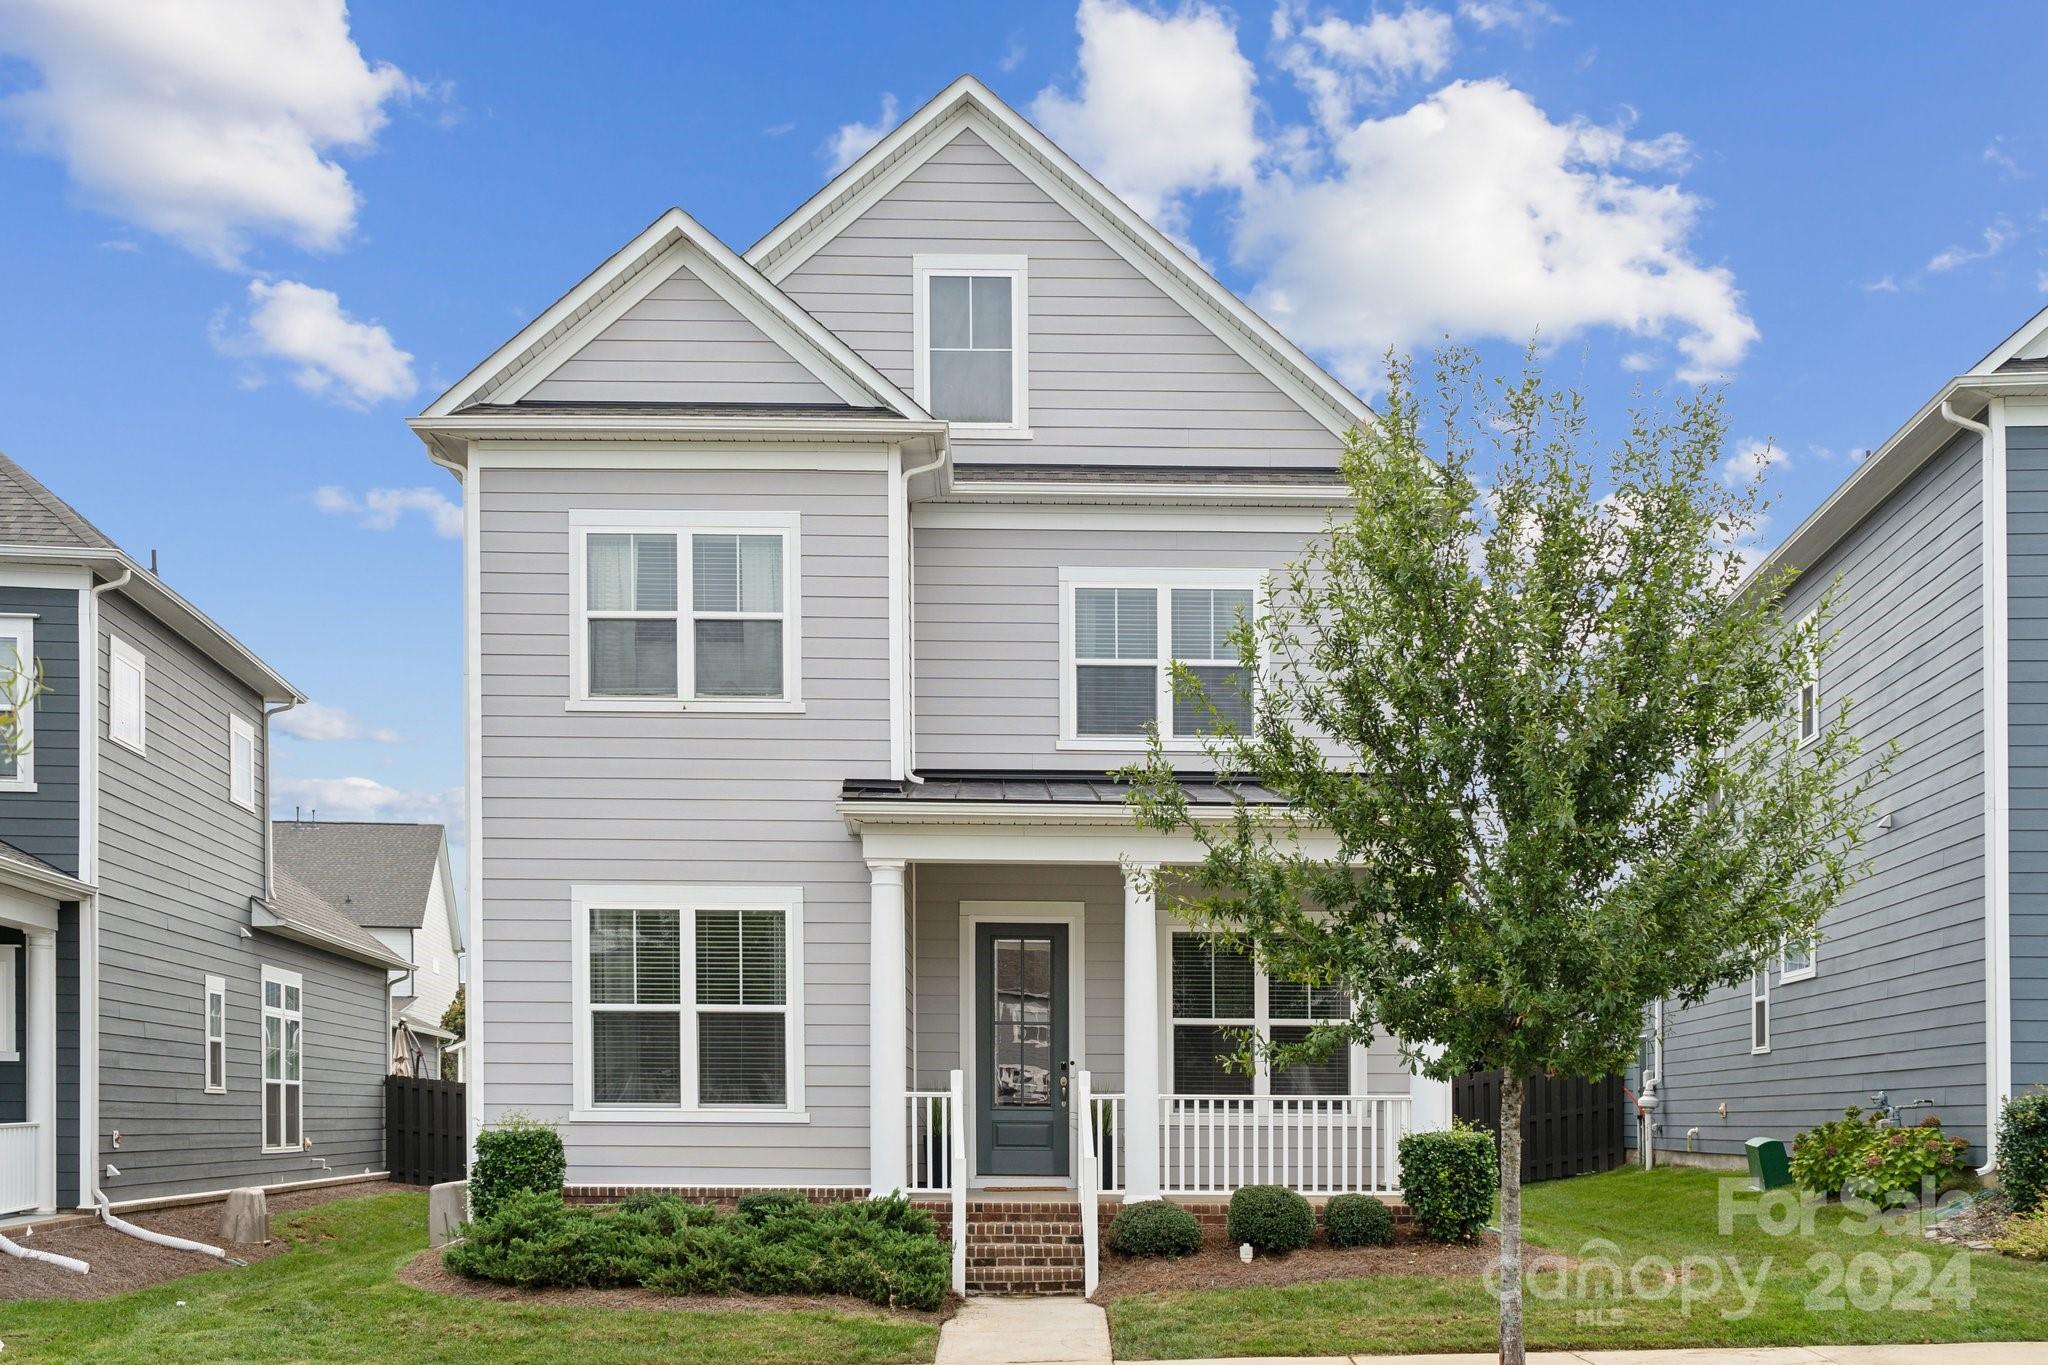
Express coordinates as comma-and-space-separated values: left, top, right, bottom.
1110, 1171, 2048, 1359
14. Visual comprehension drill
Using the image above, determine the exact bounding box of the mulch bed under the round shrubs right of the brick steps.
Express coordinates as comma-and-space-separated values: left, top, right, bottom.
1096, 1226, 1571, 1302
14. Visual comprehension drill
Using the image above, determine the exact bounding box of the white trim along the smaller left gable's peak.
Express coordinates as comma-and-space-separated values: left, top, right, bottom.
422, 209, 926, 420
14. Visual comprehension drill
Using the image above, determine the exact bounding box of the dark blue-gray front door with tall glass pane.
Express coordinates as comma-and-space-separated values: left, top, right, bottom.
975, 923, 1069, 1175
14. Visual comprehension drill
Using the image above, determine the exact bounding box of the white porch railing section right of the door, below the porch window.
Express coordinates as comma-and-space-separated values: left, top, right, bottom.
1159, 1095, 1411, 1195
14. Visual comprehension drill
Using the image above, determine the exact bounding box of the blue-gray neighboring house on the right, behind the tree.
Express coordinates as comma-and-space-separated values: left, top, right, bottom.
1638, 311, 2048, 1162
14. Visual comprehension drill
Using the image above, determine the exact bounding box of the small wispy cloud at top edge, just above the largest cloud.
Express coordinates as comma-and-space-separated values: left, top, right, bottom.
1274, 4, 1458, 135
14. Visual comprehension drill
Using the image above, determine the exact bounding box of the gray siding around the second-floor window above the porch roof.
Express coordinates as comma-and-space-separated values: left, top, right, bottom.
911, 514, 1321, 772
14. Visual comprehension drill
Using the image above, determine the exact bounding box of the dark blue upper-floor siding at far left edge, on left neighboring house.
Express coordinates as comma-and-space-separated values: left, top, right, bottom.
0, 587, 82, 876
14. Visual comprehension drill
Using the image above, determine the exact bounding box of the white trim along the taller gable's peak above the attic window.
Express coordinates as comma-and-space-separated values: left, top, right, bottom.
748, 76, 1372, 436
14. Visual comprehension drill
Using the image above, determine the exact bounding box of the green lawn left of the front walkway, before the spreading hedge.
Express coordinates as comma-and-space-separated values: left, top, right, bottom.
0, 1195, 938, 1365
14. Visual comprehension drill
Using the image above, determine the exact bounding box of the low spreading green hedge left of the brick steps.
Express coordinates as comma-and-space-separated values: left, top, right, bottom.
442, 1191, 952, 1310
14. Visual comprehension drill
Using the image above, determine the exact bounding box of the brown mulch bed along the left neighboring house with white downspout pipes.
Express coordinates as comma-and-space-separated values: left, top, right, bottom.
0, 1181, 403, 1304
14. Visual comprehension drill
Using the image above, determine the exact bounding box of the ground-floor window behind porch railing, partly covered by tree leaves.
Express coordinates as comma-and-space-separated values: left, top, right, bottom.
1171, 933, 1354, 1095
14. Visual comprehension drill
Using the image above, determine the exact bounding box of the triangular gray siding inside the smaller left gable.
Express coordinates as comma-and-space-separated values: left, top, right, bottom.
526, 255, 844, 403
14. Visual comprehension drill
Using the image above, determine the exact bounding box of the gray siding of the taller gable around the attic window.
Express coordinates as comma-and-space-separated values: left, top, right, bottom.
780, 131, 1341, 467
